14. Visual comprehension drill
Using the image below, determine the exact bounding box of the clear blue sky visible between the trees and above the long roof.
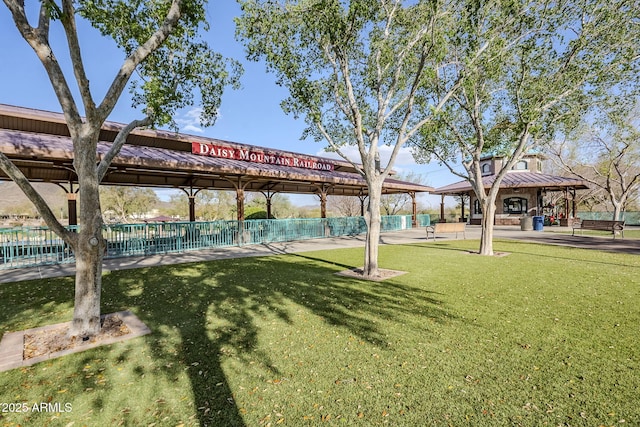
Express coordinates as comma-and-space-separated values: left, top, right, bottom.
0, 0, 459, 208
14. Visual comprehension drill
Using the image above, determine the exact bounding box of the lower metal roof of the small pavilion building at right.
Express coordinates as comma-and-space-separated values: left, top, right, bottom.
432, 171, 589, 196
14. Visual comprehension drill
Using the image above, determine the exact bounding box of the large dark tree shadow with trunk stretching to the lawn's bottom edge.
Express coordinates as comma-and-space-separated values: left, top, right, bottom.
103, 255, 452, 426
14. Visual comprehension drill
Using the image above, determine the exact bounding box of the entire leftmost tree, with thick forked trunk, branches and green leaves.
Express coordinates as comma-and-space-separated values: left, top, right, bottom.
0, 0, 238, 336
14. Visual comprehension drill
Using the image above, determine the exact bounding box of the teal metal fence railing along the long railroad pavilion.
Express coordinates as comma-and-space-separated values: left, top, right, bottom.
0, 215, 429, 269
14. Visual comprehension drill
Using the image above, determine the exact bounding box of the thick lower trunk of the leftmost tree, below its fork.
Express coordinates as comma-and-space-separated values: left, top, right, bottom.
70, 133, 106, 337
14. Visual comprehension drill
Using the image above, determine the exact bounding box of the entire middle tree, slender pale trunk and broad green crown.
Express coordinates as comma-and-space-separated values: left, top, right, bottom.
237, 0, 456, 276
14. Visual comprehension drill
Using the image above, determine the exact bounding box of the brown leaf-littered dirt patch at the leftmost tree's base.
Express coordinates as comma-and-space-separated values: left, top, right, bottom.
23, 314, 131, 360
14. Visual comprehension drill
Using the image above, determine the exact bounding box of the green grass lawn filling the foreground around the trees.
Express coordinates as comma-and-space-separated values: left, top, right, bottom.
0, 240, 640, 427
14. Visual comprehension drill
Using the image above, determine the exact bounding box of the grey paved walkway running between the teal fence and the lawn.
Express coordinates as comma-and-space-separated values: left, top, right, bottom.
0, 225, 640, 283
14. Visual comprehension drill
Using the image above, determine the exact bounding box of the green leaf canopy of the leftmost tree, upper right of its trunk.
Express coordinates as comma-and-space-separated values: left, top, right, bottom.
78, 0, 242, 129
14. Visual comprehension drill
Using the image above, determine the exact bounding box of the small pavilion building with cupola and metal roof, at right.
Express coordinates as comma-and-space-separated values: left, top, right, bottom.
432, 154, 589, 226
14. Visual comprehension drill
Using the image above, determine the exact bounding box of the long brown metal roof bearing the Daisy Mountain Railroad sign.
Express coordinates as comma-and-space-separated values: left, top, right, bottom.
0, 104, 433, 195
